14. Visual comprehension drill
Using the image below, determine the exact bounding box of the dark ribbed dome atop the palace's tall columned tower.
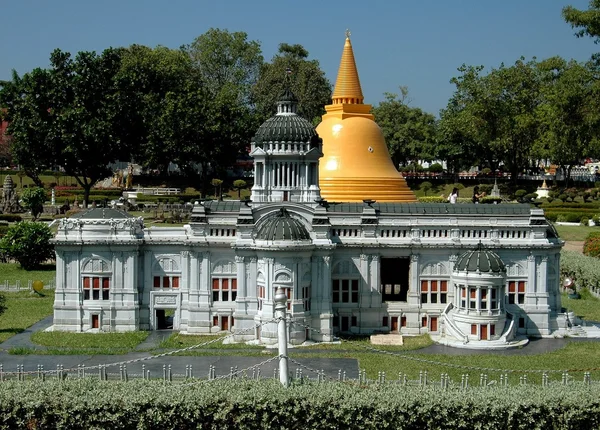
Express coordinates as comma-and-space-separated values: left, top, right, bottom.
252, 114, 319, 146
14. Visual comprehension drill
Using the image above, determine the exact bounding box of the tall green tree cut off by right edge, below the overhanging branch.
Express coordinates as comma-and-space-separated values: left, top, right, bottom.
538, 57, 600, 187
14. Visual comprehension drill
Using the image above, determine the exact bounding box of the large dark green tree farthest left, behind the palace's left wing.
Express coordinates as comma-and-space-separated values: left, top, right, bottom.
0, 49, 131, 204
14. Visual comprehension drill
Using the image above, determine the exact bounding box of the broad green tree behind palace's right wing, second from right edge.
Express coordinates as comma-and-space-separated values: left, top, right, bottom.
440, 58, 541, 182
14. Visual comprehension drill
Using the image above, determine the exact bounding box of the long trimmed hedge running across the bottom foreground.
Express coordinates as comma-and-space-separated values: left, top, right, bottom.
0, 376, 600, 430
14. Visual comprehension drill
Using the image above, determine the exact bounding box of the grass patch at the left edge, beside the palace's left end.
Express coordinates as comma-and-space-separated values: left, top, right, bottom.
0, 290, 54, 347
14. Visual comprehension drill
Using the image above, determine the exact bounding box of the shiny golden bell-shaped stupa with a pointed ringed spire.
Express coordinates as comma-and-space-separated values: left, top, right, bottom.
317, 32, 417, 202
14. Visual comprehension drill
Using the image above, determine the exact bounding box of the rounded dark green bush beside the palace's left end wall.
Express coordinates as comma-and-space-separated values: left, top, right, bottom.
0, 221, 54, 270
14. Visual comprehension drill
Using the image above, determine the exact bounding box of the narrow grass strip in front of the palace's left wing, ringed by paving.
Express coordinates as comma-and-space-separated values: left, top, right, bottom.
31, 331, 150, 354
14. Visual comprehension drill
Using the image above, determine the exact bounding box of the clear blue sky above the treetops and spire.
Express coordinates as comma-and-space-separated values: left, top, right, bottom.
0, 0, 600, 115
